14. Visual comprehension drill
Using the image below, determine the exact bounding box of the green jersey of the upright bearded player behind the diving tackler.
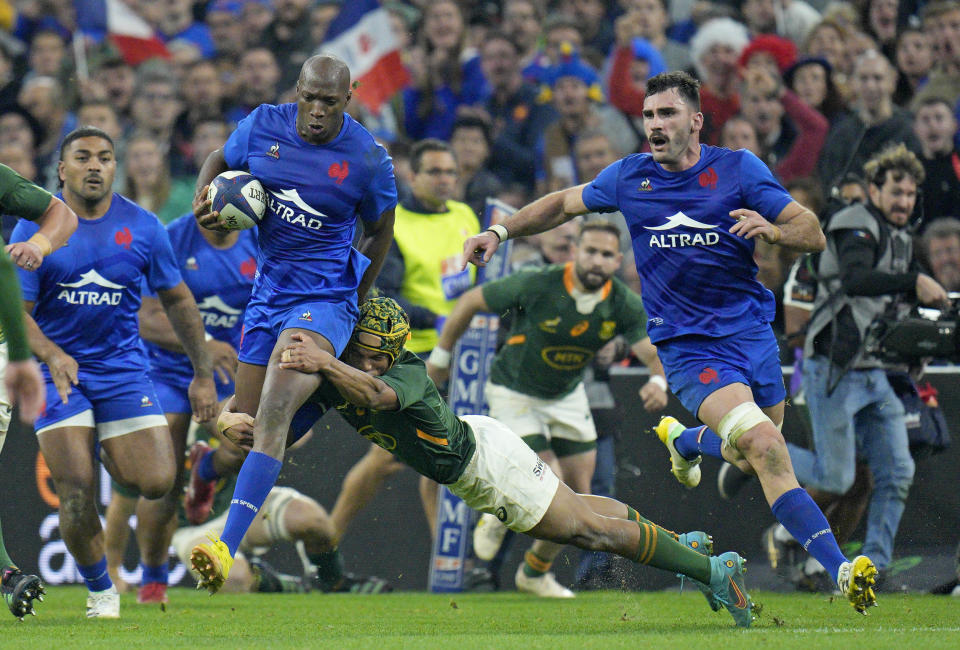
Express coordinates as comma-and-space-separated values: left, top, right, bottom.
482, 263, 647, 399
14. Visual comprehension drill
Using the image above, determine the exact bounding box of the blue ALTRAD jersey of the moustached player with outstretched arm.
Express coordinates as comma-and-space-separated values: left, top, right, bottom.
583, 145, 792, 343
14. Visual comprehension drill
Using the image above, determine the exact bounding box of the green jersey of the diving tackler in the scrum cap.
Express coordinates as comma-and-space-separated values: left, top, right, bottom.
311, 350, 477, 483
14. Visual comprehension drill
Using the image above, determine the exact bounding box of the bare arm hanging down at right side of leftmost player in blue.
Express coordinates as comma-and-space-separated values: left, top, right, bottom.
157, 280, 217, 422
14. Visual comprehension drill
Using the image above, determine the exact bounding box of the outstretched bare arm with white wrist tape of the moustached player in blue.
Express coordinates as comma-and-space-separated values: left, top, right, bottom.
461, 184, 590, 268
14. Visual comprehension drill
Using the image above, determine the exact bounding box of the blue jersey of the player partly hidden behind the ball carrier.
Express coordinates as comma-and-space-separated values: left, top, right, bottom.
143, 214, 257, 386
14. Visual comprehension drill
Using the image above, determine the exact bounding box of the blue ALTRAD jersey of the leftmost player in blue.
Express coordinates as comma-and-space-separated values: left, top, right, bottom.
11, 194, 181, 372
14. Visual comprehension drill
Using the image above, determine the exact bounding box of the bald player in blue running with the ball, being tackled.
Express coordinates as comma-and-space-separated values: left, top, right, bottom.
191, 55, 397, 592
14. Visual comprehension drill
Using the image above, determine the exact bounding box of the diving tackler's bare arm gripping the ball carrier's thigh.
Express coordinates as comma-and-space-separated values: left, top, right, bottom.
280, 333, 400, 411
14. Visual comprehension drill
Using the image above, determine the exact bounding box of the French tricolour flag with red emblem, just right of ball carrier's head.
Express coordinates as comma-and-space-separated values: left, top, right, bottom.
320, 0, 410, 113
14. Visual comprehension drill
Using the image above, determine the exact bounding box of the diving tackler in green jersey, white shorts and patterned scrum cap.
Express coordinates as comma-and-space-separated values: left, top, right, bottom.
191, 297, 753, 627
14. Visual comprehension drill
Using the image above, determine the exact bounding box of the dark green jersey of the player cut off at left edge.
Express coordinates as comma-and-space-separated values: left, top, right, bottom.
0, 164, 51, 361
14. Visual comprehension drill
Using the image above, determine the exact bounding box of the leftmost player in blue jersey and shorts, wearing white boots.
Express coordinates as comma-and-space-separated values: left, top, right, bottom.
11, 127, 217, 618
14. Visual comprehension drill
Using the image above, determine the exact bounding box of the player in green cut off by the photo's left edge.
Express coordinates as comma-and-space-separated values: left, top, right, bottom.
0, 165, 77, 620
